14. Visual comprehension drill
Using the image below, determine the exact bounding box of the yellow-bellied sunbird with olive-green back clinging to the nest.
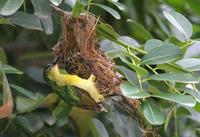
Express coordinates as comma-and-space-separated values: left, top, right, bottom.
43, 57, 107, 112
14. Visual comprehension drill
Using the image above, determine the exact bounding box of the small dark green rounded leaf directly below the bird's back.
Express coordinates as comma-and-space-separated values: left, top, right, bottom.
53, 102, 73, 120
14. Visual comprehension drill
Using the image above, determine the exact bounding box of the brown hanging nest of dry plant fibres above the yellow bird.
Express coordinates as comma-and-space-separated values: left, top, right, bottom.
53, 13, 121, 95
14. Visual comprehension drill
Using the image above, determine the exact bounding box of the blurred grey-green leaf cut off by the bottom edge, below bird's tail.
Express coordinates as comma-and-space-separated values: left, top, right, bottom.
92, 118, 109, 137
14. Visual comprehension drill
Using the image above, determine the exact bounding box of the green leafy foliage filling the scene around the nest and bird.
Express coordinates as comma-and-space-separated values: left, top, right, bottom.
0, 0, 200, 137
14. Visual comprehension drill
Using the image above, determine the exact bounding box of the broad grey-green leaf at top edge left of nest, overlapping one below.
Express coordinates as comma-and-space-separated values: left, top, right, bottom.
31, 0, 52, 18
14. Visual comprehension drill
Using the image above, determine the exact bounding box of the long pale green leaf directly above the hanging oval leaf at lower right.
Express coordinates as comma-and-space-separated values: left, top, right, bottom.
151, 93, 196, 107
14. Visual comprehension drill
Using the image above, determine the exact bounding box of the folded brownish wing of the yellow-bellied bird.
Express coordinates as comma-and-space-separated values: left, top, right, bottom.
67, 85, 100, 108
